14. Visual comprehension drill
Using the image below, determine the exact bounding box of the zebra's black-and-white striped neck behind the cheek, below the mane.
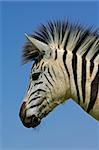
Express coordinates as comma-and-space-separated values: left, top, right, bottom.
65, 48, 99, 120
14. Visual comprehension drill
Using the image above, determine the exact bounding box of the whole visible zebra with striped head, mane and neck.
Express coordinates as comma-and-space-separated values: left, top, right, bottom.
19, 20, 99, 128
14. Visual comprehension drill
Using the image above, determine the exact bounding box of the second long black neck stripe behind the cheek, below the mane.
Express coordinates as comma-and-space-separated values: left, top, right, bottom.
72, 54, 80, 104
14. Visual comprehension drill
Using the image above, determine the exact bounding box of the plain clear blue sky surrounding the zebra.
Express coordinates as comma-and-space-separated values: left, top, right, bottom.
0, 1, 99, 150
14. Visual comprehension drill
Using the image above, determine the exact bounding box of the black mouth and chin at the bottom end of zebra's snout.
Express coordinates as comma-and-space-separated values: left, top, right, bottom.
22, 115, 41, 128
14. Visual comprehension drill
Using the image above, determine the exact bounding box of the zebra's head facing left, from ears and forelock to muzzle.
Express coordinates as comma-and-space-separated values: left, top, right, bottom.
19, 23, 70, 128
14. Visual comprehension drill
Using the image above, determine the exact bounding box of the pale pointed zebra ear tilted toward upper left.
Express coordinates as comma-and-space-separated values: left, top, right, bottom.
25, 33, 49, 53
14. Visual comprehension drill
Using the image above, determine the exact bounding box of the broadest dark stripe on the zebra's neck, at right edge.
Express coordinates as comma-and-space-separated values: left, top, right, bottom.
87, 66, 99, 113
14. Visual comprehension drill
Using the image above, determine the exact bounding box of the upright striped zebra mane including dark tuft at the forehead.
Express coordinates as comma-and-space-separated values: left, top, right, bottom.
22, 21, 99, 63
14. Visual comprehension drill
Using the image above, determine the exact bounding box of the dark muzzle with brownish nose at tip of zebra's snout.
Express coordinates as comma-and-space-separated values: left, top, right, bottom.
19, 102, 41, 128
